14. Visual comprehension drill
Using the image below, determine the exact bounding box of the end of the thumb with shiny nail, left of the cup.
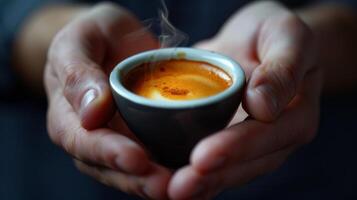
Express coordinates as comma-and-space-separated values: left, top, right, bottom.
63, 64, 115, 129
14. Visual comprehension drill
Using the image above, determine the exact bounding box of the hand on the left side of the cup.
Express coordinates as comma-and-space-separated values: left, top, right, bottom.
44, 4, 171, 199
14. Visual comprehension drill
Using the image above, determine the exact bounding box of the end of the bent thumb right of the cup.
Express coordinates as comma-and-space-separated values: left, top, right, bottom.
243, 58, 299, 121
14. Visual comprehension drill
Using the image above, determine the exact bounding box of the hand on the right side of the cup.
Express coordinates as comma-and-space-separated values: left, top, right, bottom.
168, 2, 321, 199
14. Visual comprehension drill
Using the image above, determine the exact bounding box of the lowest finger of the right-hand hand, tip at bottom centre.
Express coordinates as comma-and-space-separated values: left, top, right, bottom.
168, 147, 294, 200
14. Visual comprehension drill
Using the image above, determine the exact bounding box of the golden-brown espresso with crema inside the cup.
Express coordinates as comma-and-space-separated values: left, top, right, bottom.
123, 59, 233, 101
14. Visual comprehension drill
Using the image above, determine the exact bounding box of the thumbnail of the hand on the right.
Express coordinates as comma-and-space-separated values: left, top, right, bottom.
255, 84, 279, 115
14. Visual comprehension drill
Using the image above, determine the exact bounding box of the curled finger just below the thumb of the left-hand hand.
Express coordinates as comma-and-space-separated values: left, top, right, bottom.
47, 89, 149, 174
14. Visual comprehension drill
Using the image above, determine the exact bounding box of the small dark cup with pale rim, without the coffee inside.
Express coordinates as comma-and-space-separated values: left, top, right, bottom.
110, 48, 245, 169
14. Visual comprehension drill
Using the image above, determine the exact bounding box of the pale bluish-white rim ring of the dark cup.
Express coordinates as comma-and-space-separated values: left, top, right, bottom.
109, 47, 245, 109
